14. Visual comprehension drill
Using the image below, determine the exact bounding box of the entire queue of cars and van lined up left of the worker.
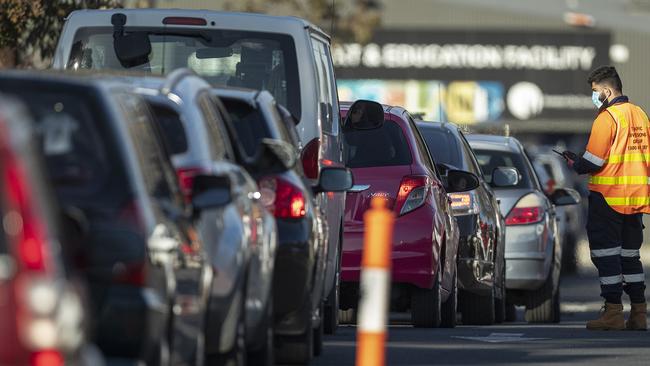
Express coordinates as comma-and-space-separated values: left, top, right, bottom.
0, 5, 578, 365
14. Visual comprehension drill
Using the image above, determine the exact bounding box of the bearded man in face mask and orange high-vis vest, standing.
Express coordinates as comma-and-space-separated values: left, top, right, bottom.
565, 66, 650, 330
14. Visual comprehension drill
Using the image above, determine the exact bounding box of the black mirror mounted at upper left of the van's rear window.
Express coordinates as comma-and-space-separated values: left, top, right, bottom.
111, 13, 151, 68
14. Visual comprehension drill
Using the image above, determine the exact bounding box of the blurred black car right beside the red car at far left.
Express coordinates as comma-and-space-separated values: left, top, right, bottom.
0, 72, 229, 365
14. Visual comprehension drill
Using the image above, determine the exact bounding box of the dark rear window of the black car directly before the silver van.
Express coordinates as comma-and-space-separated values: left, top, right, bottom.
221, 98, 270, 157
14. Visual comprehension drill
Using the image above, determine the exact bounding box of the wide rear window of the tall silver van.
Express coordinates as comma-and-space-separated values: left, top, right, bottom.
66, 27, 301, 118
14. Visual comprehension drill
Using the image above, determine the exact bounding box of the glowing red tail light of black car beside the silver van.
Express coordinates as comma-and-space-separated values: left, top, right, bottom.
259, 177, 307, 219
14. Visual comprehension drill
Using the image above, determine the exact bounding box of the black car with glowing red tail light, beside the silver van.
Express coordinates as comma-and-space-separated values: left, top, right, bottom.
213, 88, 352, 364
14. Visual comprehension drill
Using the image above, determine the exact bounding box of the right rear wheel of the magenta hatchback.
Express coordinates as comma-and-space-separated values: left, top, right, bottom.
411, 265, 441, 328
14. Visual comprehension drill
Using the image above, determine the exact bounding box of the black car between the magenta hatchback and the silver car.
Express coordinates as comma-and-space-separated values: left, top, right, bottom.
417, 122, 506, 324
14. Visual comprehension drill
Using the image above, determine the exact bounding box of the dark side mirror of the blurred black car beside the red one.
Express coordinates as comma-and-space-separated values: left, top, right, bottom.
192, 175, 232, 213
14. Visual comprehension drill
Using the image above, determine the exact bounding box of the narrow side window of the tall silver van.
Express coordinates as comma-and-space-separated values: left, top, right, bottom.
311, 37, 339, 134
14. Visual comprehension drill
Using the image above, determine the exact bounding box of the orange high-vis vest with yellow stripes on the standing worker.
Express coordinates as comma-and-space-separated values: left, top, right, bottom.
584, 103, 650, 214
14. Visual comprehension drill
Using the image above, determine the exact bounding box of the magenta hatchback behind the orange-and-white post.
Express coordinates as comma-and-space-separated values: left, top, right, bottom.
340, 102, 476, 327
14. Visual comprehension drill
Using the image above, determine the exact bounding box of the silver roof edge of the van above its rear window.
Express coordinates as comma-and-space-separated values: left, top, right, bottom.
67, 9, 330, 41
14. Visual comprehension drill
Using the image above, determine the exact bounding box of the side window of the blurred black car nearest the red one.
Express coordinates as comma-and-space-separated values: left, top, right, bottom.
118, 94, 183, 205
